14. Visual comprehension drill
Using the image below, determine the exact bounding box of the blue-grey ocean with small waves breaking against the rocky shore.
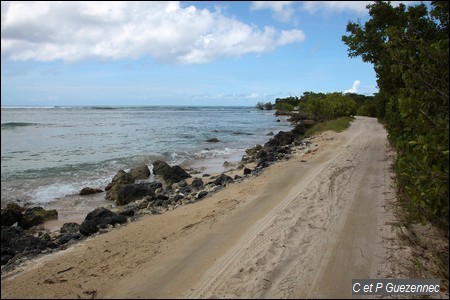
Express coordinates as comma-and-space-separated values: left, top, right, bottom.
1, 106, 291, 215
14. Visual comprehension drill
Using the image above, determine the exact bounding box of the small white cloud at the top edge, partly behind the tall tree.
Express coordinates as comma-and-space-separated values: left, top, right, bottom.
302, 1, 419, 14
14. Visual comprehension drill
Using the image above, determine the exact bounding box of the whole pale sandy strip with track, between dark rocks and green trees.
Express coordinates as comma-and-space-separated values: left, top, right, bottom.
1, 117, 422, 298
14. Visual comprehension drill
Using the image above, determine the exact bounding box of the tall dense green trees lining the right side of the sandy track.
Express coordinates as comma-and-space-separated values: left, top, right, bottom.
342, 1, 449, 234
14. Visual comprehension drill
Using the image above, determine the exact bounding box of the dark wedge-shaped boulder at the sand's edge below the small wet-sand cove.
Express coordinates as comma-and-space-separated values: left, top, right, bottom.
80, 207, 127, 236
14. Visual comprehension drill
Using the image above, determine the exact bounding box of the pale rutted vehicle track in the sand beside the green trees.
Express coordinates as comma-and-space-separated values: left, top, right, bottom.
183, 118, 386, 298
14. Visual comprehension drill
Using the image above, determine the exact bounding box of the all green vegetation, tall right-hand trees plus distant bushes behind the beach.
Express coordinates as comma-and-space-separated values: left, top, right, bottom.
255, 1, 449, 280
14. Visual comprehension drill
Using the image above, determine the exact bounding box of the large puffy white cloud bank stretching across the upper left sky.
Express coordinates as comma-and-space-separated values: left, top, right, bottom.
1, 1, 304, 64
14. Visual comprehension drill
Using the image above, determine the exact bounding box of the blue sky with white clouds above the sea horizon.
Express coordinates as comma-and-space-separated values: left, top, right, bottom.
1, 1, 418, 107
